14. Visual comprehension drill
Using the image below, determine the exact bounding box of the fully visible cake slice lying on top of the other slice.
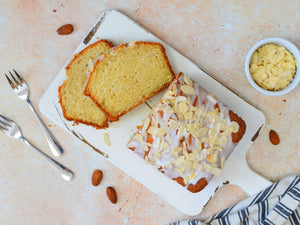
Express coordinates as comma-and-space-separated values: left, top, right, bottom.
84, 42, 175, 121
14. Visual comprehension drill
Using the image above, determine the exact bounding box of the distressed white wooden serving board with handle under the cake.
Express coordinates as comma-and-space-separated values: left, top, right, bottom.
39, 10, 271, 215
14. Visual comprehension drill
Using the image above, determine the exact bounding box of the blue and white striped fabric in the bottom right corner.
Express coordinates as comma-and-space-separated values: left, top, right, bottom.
171, 176, 300, 225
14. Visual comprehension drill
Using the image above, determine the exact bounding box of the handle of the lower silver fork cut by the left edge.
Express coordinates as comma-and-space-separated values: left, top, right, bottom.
20, 137, 74, 181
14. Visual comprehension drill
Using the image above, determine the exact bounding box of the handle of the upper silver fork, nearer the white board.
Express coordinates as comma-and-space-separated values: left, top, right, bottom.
26, 99, 63, 157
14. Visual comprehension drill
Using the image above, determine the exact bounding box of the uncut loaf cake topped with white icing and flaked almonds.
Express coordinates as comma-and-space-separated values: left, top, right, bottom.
127, 73, 246, 193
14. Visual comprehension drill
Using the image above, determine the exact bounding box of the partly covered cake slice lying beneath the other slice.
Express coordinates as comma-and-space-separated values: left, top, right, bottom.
58, 40, 112, 128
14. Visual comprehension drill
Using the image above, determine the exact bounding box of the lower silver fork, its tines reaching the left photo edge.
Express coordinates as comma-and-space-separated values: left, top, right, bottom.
0, 115, 74, 181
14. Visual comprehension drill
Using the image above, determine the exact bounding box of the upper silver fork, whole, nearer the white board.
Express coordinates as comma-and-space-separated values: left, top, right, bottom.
5, 69, 63, 157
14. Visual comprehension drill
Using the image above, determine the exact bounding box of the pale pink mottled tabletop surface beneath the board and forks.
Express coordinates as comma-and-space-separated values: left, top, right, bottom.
0, 0, 300, 224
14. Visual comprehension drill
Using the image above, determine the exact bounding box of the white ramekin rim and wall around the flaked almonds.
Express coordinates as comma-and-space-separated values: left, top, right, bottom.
245, 37, 300, 96
